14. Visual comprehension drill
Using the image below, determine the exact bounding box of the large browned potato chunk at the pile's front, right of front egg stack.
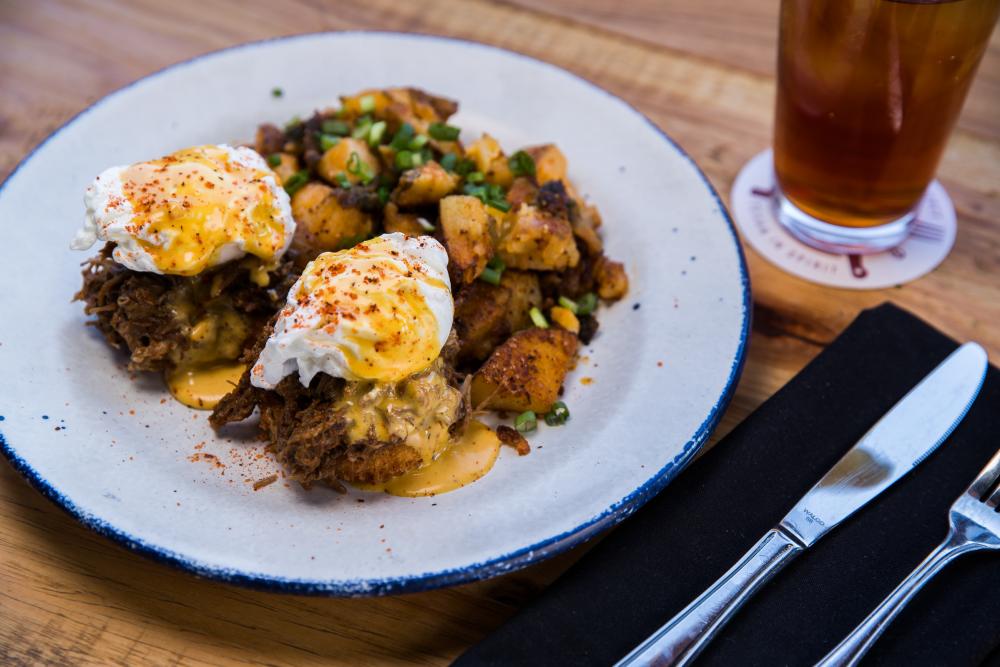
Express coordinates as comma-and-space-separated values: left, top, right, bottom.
472, 328, 579, 414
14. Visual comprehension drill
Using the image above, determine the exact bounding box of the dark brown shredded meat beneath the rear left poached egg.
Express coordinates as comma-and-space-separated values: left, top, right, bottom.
74, 243, 295, 371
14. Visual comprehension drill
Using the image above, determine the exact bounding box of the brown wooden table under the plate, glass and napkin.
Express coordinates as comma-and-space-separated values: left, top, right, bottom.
0, 0, 1000, 665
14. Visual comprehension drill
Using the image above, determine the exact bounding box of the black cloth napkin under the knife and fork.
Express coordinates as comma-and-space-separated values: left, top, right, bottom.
456, 305, 1000, 667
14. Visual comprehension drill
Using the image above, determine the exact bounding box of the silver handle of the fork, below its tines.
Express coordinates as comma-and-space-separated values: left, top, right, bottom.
816, 532, 983, 667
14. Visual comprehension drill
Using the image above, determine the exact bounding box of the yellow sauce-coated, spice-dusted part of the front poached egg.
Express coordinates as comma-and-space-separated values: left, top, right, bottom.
289, 238, 450, 382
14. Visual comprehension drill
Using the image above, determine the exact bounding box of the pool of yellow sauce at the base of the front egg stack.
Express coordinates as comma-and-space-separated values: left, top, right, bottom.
361, 421, 500, 497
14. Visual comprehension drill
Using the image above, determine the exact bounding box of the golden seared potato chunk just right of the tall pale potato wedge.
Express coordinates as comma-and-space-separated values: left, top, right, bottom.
497, 204, 580, 271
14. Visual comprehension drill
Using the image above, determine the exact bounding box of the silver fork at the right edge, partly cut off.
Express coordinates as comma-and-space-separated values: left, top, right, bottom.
816, 451, 1000, 667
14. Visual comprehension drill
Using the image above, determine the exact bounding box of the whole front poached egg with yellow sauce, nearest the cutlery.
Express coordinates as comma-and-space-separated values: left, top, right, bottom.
250, 232, 455, 389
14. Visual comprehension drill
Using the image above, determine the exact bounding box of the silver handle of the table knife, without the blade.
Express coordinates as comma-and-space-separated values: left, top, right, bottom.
618, 528, 804, 667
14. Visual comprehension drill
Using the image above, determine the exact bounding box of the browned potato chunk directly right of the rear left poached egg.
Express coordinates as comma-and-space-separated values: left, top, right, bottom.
292, 181, 372, 254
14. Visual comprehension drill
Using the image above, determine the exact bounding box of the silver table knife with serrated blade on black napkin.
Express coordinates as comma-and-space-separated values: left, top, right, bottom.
617, 343, 987, 667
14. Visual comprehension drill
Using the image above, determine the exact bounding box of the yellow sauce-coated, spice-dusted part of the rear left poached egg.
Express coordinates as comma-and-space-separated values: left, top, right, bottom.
120, 146, 285, 276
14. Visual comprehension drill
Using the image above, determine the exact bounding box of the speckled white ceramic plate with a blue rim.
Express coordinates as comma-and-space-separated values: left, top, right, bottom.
0, 33, 750, 595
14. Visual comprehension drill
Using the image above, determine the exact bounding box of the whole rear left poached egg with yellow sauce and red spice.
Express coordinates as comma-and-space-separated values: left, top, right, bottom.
72, 144, 295, 276
